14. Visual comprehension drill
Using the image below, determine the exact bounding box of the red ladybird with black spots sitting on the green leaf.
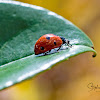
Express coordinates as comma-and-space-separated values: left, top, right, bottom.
34, 34, 69, 55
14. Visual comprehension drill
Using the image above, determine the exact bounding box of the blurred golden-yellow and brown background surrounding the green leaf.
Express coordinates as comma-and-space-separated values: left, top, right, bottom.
0, 0, 100, 100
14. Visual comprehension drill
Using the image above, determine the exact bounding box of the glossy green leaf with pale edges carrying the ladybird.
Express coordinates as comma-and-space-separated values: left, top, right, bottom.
0, 1, 96, 90
